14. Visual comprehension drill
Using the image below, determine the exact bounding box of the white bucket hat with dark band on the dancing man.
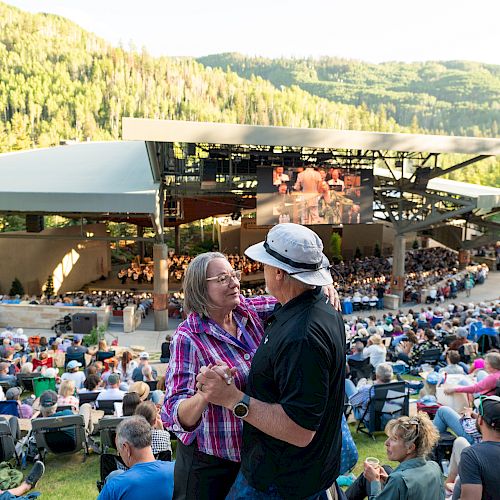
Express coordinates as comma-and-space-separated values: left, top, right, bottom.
245, 222, 333, 286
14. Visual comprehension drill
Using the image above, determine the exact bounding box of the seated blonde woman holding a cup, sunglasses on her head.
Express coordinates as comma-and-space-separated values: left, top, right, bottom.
346, 412, 445, 500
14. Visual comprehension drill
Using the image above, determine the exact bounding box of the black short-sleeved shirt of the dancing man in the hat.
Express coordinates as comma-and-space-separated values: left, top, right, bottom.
241, 288, 345, 499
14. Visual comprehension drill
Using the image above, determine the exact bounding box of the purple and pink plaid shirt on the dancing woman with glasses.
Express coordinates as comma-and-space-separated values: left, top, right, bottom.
161, 296, 277, 462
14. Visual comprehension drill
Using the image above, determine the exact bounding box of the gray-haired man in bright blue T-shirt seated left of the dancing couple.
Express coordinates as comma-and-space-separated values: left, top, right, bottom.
98, 415, 174, 500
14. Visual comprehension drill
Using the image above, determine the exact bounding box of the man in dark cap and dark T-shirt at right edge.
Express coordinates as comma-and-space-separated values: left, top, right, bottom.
453, 396, 500, 500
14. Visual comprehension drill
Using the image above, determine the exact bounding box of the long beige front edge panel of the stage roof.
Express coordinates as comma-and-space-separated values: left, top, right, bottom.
122, 118, 500, 156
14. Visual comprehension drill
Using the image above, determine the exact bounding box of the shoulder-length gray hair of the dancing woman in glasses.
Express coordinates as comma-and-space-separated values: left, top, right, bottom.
183, 252, 227, 318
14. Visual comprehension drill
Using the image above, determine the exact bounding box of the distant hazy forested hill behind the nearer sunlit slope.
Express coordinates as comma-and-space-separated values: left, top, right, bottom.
198, 53, 500, 137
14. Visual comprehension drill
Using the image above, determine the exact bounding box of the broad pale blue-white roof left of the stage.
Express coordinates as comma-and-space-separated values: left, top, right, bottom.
0, 141, 159, 214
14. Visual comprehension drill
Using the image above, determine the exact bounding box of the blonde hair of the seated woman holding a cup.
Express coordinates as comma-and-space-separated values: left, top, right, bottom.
385, 412, 439, 457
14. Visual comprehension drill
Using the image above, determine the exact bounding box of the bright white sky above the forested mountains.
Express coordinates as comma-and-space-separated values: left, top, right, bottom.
3, 0, 500, 64
